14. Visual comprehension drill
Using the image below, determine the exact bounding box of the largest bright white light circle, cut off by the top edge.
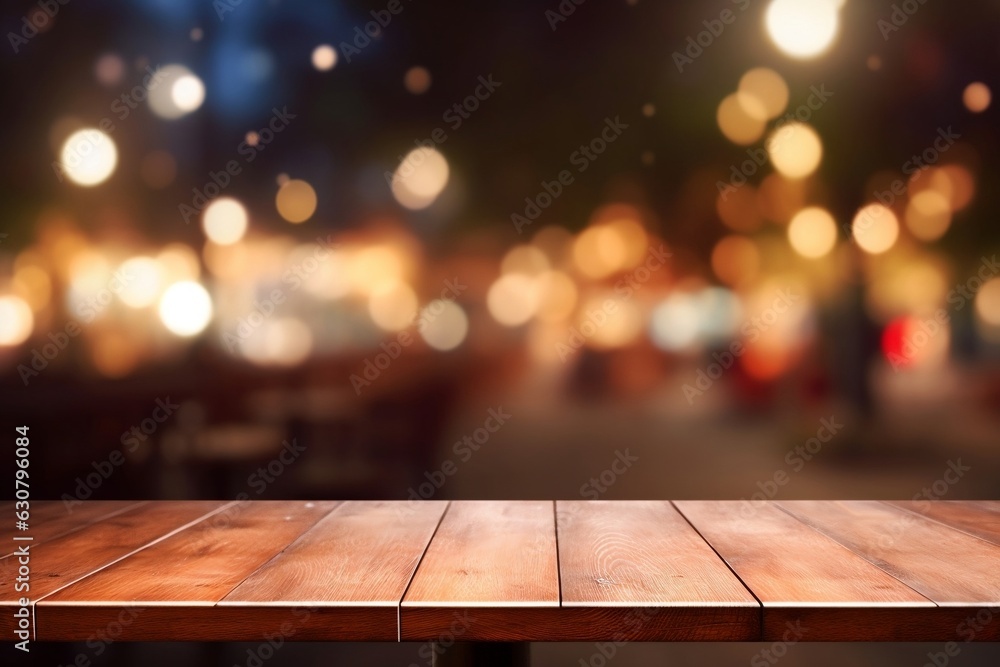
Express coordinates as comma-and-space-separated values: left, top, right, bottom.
764, 0, 840, 59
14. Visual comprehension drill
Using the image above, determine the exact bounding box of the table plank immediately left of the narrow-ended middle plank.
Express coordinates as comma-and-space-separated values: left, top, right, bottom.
223, 501, 448, 641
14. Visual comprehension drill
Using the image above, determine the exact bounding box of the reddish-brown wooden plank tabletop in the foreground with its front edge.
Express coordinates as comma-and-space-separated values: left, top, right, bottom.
0, 501, 1000, 641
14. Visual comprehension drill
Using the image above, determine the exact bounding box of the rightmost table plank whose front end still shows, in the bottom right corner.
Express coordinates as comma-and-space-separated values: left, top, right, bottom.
778, 500, 1000, 641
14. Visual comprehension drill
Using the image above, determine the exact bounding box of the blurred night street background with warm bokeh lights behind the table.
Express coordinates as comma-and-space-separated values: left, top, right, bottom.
0, 0, 1000, 665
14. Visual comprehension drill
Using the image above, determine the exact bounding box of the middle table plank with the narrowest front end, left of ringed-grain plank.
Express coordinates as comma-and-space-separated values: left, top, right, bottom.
400, 501, 559, 641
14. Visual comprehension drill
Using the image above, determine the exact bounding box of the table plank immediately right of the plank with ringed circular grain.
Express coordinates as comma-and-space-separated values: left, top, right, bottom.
674, 501, 954, 641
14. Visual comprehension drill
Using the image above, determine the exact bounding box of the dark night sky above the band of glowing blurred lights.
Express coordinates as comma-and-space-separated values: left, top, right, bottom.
0, 0, 1000, 254
